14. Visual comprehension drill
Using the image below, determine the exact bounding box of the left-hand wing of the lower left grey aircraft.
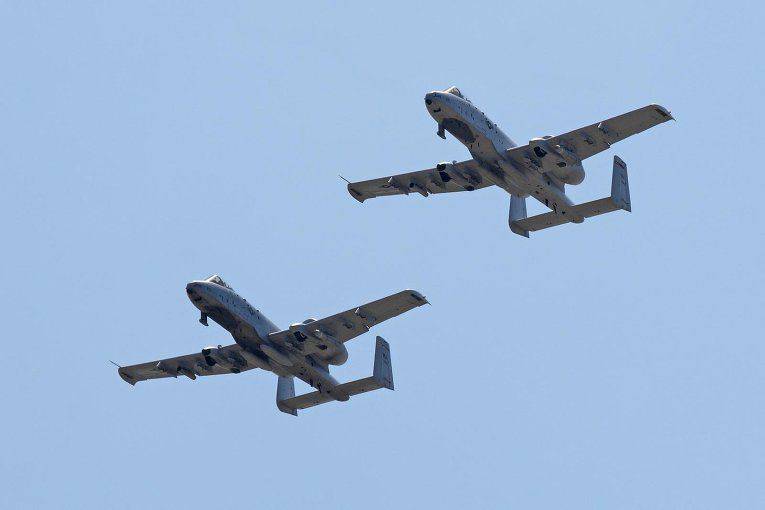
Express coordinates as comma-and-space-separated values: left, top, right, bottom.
117, 344, 255, 384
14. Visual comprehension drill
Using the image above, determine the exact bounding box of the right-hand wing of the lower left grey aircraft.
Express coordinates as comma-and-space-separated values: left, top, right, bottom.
268, 290, 428, 345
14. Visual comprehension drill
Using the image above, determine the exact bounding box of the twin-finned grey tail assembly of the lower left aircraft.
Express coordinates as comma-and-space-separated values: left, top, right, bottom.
276, 336, 393, 415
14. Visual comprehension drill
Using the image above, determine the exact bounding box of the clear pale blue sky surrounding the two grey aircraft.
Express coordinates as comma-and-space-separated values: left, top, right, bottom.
0, 1, 765, 509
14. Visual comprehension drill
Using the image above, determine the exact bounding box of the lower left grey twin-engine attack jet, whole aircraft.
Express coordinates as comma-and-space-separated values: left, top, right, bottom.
118, 275, 428, 416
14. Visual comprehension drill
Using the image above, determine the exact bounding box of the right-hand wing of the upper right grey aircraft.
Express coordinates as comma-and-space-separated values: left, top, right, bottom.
547, 104, 674, 163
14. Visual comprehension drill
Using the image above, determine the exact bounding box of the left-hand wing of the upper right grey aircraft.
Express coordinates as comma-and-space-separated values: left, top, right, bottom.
348, 159, 492, 202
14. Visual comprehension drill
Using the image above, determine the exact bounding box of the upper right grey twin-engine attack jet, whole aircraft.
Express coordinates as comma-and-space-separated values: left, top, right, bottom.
348, 87, 673, 237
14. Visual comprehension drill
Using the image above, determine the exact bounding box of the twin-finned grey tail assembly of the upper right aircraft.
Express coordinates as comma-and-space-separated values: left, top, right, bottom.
510, 156, 632, 235
